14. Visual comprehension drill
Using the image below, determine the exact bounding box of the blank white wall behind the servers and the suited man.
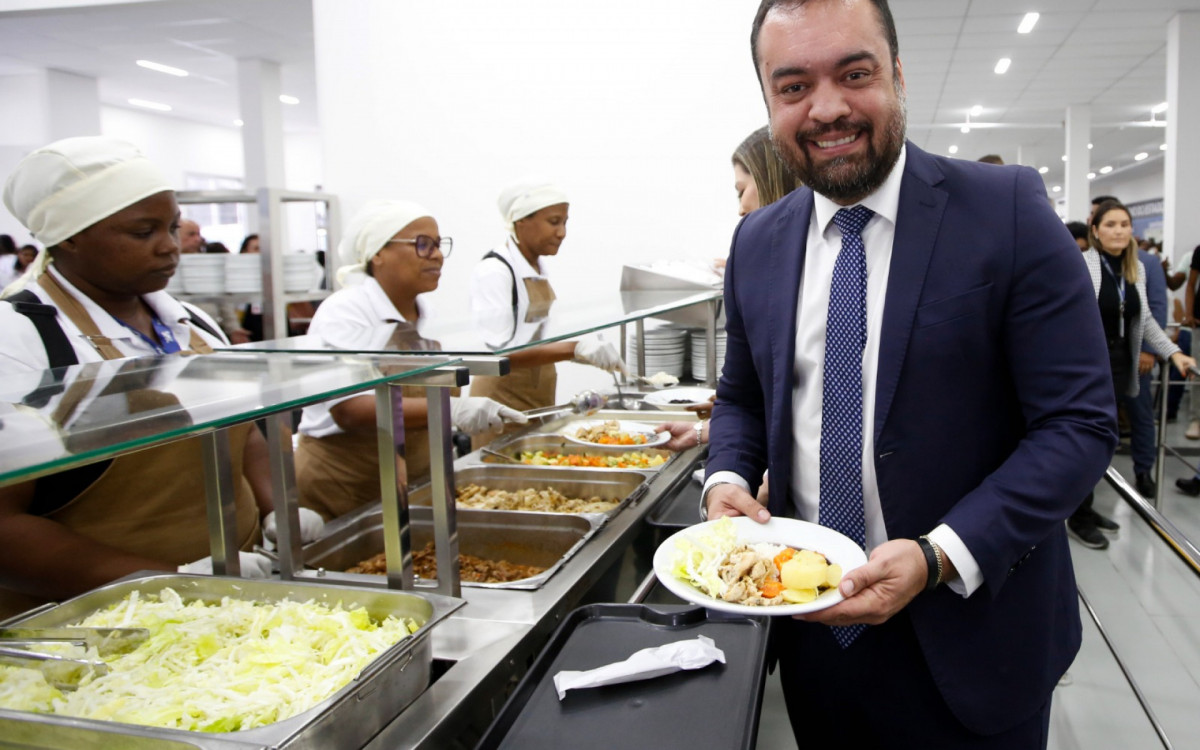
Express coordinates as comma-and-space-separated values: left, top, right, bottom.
313, 0, 767, 305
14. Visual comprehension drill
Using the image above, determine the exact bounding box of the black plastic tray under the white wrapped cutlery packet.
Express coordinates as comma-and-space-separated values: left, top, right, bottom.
476, 604, 768, 750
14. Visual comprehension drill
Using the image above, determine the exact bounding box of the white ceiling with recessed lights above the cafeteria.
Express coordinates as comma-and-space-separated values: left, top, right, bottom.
0, 0, 1200, 185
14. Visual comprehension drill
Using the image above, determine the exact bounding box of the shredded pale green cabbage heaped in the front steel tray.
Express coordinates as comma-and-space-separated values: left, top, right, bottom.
0, 588, 420, 732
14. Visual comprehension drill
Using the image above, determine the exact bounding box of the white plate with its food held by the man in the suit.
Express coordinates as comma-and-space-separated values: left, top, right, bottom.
654, 516, 866, 616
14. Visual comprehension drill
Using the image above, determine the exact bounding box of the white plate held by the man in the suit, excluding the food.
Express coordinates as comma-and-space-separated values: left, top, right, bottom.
654, 516, 866, 616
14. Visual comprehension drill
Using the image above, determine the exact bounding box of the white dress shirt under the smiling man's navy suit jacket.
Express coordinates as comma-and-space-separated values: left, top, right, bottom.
704, 149, 983, 596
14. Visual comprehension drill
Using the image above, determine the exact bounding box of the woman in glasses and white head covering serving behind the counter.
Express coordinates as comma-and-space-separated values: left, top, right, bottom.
296, 195, 526, 520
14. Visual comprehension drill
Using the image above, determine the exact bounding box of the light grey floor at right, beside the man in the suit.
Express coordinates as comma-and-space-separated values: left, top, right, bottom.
757, 422, 1200, 750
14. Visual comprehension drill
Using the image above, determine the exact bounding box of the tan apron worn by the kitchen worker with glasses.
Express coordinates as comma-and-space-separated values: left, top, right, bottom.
295, 385, 441, 521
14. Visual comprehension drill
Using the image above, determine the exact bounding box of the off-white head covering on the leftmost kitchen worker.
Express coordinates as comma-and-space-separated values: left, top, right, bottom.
4, 136, 172, 295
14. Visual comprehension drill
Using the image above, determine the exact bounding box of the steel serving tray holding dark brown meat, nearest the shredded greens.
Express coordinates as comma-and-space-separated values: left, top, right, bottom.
304, 504, 604, 590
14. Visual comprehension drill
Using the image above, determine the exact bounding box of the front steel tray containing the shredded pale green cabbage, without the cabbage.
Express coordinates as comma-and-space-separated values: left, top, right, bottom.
0, 572, 464, 750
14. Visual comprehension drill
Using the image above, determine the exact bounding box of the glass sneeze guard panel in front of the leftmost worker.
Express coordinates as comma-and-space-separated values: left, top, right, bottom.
0, 352, 458, 485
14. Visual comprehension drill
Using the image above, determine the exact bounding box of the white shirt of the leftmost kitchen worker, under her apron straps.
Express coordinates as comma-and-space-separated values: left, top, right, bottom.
0, 264, 226, 374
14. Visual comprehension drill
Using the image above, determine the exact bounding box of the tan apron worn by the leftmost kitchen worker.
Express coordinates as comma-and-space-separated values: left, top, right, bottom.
0, 274, 258, 617
